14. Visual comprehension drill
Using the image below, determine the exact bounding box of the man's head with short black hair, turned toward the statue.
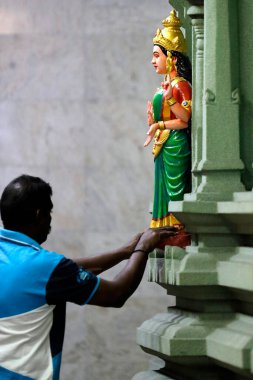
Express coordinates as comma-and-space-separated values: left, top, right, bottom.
0, 175, 53, 244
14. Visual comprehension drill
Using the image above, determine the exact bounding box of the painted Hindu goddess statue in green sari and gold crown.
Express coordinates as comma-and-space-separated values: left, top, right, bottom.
144, 10, 192, 245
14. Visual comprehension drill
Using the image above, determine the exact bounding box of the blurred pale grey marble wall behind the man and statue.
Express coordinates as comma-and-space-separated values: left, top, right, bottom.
0, 0, 173, 380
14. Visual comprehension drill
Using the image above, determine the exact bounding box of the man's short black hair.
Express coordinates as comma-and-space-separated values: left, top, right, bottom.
0, 174, 53, 230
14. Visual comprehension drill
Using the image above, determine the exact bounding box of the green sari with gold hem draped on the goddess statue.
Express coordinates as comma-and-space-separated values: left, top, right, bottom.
150, 84, 191, 228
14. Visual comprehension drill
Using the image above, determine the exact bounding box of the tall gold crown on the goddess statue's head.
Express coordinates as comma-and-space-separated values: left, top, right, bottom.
153, 10, 187, 53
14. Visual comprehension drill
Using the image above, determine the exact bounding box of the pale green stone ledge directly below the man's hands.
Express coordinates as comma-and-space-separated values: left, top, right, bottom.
148, 246, 253, 291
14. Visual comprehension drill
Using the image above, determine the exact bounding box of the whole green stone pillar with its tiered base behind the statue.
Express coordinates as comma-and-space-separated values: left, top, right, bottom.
133, 0, 253, 380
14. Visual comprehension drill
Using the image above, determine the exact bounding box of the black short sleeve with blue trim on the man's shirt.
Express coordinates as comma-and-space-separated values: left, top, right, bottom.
46, 258, 100, 305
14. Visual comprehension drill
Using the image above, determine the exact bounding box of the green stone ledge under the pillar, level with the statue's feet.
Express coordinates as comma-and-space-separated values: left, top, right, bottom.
167, 191, 253, 236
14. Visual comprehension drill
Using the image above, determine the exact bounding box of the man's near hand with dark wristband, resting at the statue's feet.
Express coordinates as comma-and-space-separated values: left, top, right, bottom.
134, 227, 178, 253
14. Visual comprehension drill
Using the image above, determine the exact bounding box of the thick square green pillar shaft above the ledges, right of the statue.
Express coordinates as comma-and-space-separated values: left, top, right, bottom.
197, 0, 243, 199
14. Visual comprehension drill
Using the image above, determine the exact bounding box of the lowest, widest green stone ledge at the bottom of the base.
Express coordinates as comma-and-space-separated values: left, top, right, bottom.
134, 308, 253, 380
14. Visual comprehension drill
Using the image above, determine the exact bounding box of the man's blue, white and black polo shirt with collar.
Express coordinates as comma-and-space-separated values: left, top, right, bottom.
0, 229, 99, 380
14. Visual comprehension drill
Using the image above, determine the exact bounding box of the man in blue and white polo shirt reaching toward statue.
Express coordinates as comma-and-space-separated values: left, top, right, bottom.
0, 175, 175, 380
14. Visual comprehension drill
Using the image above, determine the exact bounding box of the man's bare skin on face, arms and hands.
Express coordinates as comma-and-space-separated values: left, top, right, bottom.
20, 203, 177, 307
